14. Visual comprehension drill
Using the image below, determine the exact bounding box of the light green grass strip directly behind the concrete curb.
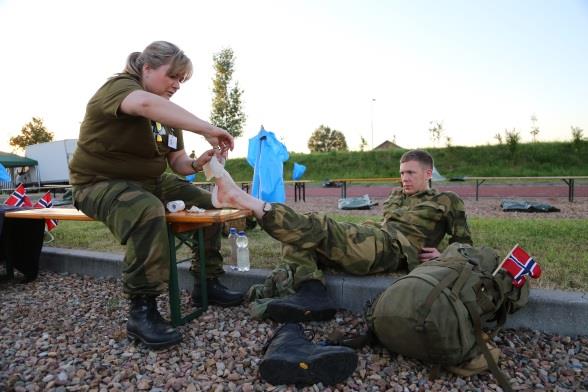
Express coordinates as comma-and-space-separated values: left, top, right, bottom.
49, 214, 588, 291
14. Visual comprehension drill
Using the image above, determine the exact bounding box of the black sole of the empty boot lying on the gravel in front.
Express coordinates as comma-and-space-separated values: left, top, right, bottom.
259, 350, 358, 385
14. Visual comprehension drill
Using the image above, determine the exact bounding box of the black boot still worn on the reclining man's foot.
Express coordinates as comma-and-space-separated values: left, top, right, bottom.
265, 279, 337, 323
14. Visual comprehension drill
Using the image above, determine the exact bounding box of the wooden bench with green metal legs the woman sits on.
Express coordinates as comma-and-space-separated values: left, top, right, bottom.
4, 208, 252, 326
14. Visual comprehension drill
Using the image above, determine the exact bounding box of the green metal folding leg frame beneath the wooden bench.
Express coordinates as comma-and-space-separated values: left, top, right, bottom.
168, 225, 208, 326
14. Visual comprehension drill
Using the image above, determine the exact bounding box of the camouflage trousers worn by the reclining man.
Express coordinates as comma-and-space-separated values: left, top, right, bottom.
261, 203, 406, 287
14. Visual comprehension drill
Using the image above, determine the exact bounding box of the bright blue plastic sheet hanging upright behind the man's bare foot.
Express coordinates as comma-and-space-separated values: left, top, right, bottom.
247, 126, 289, 203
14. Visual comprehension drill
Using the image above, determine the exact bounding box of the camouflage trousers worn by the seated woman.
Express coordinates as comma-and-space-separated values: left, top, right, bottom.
73, 173, 224, 296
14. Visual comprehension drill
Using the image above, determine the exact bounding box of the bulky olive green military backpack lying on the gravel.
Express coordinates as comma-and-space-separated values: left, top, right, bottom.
367, 243, 529, 389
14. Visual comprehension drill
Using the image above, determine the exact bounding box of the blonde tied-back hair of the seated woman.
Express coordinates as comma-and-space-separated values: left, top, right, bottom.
124, 41, 192, 82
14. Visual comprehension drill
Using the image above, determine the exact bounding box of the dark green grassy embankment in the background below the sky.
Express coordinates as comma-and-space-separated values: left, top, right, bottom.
222, 141, 588, 181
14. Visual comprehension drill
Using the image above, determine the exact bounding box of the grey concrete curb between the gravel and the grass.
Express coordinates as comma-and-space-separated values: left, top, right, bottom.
40, 247, 588, 336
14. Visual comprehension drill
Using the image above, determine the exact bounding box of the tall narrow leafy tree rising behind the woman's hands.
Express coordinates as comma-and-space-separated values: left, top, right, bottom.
210, 48, 246, 137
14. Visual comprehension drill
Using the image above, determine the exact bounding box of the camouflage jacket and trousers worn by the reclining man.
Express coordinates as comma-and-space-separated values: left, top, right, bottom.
260, 189, 472, 287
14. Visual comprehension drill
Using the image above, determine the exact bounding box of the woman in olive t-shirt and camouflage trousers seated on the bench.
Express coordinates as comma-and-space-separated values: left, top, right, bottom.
70, 41, 242, 348
